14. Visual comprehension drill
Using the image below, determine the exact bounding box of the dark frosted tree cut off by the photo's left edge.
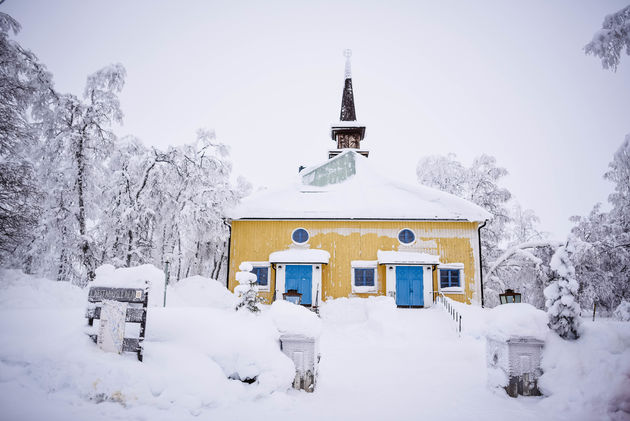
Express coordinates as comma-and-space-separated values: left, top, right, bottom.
0, 13, 52, 263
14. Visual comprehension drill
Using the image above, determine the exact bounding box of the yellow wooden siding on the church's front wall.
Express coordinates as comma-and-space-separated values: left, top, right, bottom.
228, 220, 477, 303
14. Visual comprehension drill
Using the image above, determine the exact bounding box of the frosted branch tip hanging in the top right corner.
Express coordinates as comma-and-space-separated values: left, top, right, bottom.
584, 6, 630, 71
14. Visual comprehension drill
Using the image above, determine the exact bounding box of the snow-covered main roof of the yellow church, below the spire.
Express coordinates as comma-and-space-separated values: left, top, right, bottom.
228, 150, 491, 221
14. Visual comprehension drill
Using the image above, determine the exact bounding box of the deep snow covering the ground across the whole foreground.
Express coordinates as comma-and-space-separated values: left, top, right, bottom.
0, 271, 630, 421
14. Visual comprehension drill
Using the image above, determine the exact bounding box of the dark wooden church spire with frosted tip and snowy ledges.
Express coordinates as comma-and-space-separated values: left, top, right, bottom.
328, 50, 369, 158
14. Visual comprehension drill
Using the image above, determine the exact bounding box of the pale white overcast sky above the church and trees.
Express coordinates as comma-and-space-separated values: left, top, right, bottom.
0, 0, 630, 237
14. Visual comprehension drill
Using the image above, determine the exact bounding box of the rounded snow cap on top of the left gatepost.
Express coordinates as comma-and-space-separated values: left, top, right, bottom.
269, 300, 322, 338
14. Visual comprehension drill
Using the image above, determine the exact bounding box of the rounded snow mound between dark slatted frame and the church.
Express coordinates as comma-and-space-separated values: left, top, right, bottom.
166, 275, 236, 310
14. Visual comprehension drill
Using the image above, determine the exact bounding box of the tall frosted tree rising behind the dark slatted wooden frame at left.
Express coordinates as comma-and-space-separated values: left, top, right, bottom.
29, 65, 125, 285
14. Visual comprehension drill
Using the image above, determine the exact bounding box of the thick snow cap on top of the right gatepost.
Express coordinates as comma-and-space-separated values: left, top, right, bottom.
486, 303, 549, 340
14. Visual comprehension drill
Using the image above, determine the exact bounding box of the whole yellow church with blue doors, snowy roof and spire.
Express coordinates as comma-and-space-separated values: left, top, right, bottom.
228, 54, 491, 308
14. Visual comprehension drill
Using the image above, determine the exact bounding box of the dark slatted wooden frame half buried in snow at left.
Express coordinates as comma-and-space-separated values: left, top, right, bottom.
85, 284, 149, 361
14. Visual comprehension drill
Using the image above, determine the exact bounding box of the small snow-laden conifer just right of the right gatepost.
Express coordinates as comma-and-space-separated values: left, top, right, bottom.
544, 239, 580, 339
